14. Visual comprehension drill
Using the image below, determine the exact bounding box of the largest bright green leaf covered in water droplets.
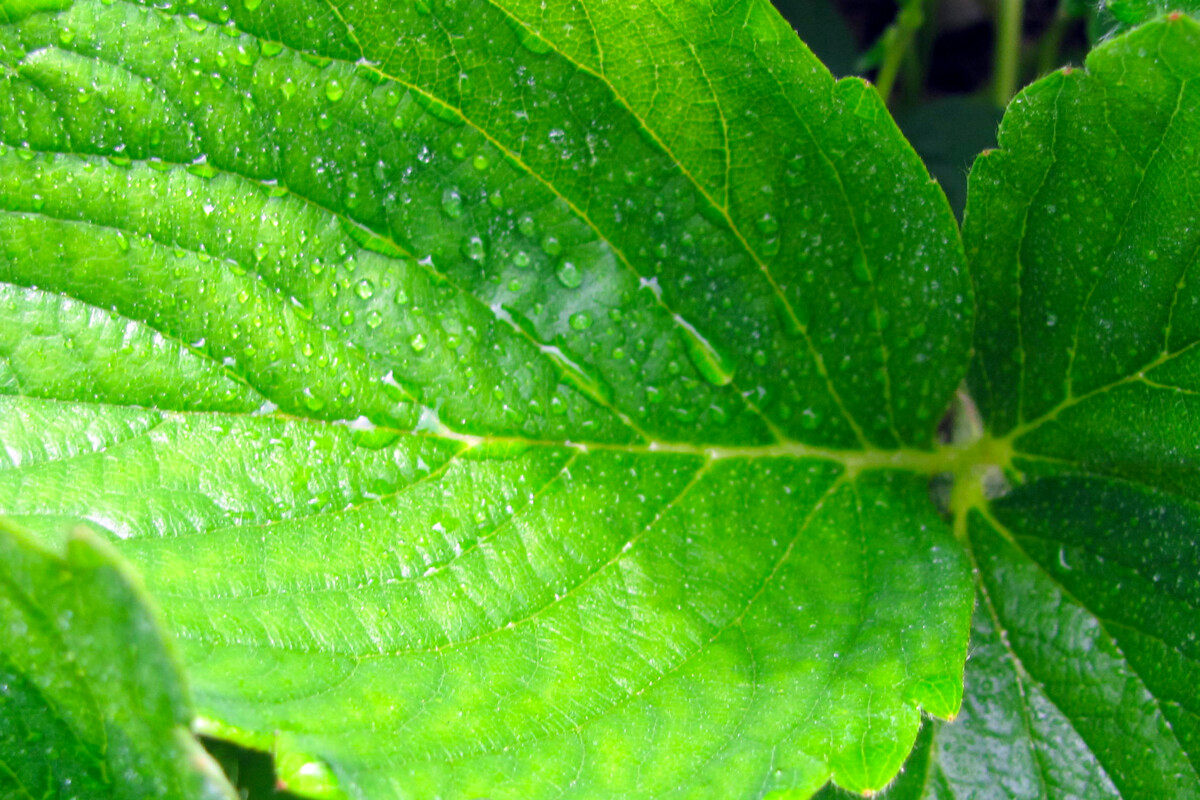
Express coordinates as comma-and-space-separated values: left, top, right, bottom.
0, 0, 972, 799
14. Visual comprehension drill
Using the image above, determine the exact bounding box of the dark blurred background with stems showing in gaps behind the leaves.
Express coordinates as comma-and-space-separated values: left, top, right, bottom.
204, 0, 1099, 800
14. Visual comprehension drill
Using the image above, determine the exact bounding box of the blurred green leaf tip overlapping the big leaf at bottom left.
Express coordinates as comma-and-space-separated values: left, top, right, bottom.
0, 523, 236, 800
